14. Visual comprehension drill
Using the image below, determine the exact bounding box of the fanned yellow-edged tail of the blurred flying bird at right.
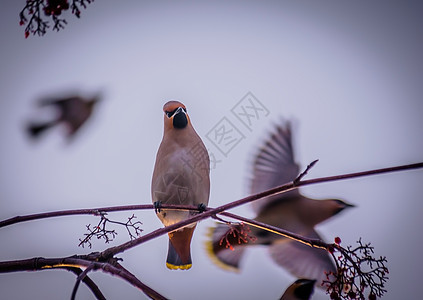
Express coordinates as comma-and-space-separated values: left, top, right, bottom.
206, 223, 248, 272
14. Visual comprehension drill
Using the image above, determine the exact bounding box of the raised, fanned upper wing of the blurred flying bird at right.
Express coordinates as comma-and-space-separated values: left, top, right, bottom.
250, 122, 299, 213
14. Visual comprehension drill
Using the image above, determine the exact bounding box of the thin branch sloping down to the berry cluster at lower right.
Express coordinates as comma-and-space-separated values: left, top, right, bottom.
217, 212, 389, 300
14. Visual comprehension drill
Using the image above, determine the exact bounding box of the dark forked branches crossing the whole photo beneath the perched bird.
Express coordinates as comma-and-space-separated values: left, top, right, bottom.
0, 163, 423, 299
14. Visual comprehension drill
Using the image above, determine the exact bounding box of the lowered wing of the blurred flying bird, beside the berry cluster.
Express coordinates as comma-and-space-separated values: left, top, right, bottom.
269, 230, 336, 286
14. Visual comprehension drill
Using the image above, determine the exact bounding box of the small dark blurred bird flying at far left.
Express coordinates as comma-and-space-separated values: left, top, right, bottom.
27, 95, 100, 138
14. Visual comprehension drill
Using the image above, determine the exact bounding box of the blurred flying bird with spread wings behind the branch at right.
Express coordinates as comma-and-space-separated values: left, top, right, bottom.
207, 123, 352, 283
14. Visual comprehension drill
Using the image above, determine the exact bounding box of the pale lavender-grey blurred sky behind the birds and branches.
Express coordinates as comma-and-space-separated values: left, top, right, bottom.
0, 0, 423, 299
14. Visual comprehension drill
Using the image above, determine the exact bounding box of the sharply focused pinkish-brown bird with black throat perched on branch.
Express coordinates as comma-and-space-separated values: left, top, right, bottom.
151, 101, 210, 269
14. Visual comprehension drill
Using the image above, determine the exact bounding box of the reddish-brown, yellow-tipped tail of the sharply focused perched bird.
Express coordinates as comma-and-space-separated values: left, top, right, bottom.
166, 225, 195, 270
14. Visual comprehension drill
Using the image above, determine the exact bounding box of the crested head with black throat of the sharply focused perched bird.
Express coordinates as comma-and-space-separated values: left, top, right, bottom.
163, 101, 191, 131
